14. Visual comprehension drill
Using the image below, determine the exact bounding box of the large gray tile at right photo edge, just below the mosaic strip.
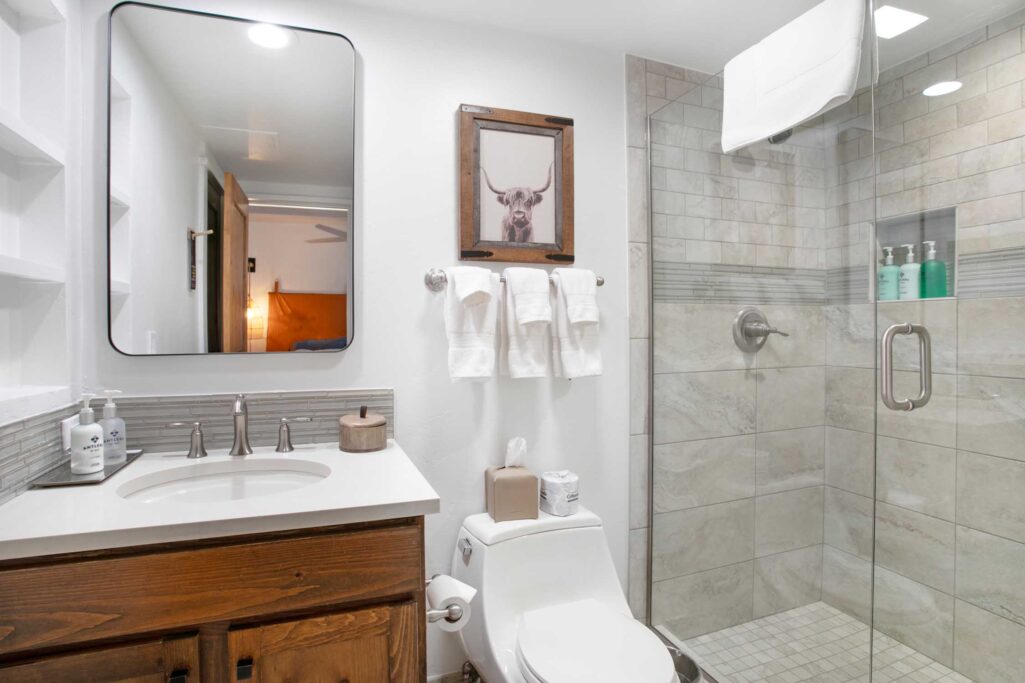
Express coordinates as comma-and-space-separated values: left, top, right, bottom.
957, 297, 1025, 378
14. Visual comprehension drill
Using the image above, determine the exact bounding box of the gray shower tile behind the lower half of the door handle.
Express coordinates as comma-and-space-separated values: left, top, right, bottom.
876, 372, 957, 448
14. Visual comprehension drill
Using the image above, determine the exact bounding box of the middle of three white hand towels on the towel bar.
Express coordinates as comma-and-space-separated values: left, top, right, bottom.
500, 268, 551, 378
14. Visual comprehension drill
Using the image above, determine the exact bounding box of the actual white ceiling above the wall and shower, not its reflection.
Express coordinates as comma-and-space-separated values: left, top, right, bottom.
346, 0, 1025, 74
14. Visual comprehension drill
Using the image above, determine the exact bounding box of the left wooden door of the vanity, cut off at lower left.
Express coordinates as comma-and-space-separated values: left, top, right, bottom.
0, 637, 200, 683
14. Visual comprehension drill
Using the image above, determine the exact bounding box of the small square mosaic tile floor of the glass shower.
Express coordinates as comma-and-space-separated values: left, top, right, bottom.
659, 602, 972, 683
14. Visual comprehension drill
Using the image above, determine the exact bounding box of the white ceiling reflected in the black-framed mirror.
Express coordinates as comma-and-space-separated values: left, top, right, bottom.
114, 5, 355, 193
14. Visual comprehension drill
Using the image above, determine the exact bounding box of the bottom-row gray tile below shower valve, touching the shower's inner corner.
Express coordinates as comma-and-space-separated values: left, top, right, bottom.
754, 545, 822, 618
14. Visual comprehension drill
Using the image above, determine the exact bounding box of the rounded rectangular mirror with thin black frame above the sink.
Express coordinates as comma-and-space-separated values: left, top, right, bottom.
108, 3, 355, 355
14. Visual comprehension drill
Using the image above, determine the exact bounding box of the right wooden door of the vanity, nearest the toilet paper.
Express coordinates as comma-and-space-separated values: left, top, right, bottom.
228, 602, 422, 683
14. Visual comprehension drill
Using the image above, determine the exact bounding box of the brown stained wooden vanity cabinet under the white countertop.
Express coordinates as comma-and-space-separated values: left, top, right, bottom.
0, 517, 426, 683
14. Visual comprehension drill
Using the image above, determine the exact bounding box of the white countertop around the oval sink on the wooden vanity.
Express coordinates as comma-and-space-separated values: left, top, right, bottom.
0, 440, 440, 560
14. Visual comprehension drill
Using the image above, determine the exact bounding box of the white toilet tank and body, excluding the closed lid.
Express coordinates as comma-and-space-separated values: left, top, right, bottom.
452, 507, 630, 680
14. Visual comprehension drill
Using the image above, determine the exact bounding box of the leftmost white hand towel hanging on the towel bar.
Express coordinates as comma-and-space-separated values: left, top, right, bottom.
445, 268, 500, 380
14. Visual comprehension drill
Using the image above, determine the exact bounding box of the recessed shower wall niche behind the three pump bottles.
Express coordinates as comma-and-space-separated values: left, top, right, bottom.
872, 207, 957, 304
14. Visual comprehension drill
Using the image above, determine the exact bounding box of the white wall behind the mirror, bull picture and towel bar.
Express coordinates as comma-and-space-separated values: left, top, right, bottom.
81, 0, 628, 674
